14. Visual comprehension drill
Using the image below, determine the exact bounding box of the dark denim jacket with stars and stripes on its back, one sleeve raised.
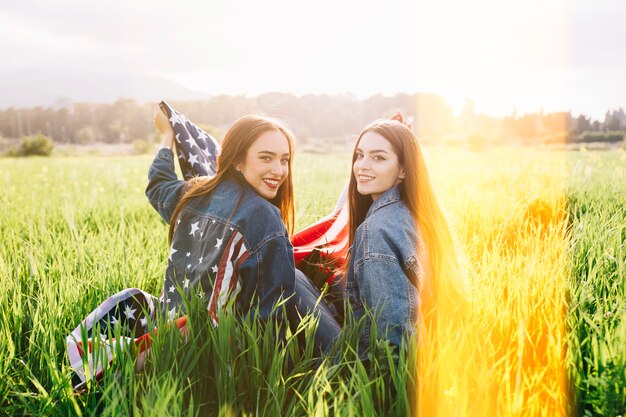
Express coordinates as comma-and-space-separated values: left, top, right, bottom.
146, 149, 295, 324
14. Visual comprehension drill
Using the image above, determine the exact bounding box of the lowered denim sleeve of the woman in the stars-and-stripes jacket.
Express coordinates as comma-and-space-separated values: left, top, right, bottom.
241, 234, 296, 319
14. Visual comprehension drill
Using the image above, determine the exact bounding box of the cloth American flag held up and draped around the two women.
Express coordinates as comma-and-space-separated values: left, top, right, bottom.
66, 102, 348, 391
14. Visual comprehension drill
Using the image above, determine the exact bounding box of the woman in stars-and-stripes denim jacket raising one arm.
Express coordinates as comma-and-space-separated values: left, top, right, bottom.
146, 107, 340, 353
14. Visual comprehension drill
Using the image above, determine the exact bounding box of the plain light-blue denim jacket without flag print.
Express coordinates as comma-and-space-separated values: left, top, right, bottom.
346, 185, 426, 351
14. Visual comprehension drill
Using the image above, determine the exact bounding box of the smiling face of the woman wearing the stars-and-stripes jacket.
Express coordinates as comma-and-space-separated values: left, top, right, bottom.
235, 130, 291, 200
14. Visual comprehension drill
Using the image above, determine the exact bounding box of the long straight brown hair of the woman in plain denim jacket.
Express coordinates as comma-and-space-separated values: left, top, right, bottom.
348, 120, 464, 314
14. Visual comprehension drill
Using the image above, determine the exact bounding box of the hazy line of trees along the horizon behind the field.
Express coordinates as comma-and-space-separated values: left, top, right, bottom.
0, 93, 626, 144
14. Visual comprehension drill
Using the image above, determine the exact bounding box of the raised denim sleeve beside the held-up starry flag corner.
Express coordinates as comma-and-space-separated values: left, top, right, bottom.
146, 148, 185, 224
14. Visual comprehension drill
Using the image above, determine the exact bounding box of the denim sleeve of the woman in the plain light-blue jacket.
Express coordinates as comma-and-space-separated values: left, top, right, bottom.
358, 253, 419, 346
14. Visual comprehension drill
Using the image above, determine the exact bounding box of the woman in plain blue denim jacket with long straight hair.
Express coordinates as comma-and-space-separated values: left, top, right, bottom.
346, 120, 458, 348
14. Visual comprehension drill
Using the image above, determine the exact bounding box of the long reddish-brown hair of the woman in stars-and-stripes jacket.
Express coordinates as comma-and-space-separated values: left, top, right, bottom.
169, 115, 294, 243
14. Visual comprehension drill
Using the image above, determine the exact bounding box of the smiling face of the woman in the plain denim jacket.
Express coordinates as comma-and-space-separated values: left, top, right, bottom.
352, 131, 404, 201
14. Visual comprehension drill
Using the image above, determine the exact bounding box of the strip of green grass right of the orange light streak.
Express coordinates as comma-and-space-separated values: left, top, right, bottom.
568, 154, 626, 416
